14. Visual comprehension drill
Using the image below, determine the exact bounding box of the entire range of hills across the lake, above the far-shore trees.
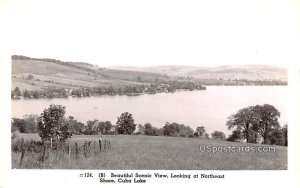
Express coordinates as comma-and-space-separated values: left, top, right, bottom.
12, 55, 287, 94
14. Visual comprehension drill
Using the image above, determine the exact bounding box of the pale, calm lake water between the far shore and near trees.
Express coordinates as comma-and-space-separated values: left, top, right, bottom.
12, 86, 288, 134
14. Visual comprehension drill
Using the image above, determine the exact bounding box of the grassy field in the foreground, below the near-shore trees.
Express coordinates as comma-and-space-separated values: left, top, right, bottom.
12, 134, 287, 170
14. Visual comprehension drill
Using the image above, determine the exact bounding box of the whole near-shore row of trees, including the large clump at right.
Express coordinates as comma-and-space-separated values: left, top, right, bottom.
11, 104, 287, 145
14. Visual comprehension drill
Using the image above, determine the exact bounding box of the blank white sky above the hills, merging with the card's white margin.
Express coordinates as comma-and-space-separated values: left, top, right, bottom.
0, 0, 300, 67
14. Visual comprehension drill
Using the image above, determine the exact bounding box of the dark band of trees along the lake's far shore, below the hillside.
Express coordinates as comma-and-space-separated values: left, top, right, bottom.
11, 81, 206, 99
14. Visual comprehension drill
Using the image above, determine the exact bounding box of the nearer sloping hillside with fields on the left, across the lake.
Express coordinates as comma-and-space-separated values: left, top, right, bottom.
12, 56, 170, 91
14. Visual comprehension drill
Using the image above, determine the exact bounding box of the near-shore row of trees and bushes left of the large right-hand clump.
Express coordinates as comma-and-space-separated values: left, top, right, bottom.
11, 104, 225, 141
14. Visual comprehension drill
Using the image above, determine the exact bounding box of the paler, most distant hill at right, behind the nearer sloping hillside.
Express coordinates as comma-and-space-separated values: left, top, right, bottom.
109, 65, 288, 82
